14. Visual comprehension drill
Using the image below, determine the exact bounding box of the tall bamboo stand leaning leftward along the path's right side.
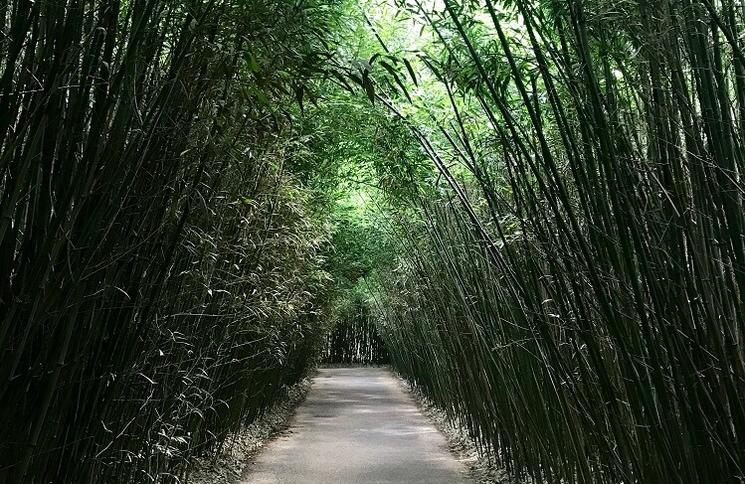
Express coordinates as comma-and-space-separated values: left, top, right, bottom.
375, 0, 745, 483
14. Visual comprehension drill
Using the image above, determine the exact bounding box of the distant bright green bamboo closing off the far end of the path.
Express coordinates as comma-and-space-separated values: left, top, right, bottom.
290, 90, 412, 364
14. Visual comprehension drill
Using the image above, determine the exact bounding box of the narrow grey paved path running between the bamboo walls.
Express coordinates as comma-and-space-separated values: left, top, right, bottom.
243, 368, 469, 484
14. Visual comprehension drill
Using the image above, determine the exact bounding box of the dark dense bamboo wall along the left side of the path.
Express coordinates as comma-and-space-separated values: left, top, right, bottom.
0, 0, 338, 483
